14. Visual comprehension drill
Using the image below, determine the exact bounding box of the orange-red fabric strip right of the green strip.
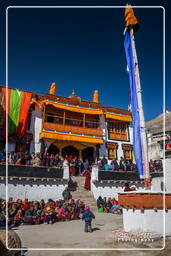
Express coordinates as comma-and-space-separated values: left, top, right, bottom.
17, 92, 32, 138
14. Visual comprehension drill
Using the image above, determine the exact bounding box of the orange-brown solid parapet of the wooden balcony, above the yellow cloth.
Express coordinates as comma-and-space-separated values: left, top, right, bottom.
43, 122, 103, 136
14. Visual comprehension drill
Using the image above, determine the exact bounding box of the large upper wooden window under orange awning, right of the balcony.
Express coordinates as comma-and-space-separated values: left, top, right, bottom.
108, 121, 129, 141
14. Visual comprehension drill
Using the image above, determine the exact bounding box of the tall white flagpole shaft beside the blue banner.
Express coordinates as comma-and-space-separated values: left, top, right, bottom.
130, 27, 150, 187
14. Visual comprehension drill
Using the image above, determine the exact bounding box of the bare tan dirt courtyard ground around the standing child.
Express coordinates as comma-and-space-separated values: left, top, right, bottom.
12, 213, 171, 256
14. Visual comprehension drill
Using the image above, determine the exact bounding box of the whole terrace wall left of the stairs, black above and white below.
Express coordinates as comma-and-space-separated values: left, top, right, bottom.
0, 165, 69, 201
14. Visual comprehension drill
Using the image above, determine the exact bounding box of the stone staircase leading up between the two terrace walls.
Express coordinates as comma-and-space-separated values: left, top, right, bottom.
69, 176, 97, 211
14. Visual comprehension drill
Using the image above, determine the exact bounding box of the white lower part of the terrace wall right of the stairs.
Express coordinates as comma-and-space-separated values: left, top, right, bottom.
91, 182, 145, 200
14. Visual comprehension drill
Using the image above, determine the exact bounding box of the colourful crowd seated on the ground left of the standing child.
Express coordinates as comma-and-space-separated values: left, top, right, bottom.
0, 198, 85, 226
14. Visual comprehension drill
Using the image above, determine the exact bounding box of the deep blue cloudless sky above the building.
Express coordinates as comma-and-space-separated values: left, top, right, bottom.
0, 1, 171, 120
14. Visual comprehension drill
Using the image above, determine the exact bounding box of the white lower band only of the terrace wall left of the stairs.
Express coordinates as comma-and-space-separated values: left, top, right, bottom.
0, 181, 68, 201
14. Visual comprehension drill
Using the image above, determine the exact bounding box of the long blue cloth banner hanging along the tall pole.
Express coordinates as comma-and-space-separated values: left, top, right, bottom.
124, 31, 144, 178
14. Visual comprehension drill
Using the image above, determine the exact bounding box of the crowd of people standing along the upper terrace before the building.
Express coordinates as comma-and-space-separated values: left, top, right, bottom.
0, 152, 163, 176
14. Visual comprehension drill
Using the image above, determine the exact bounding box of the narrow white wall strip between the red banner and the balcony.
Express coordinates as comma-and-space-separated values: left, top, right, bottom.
29, 105, 42, 153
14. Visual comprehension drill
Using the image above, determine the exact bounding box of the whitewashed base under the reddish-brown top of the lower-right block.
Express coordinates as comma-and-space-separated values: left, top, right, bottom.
123, 209, 171, 235
